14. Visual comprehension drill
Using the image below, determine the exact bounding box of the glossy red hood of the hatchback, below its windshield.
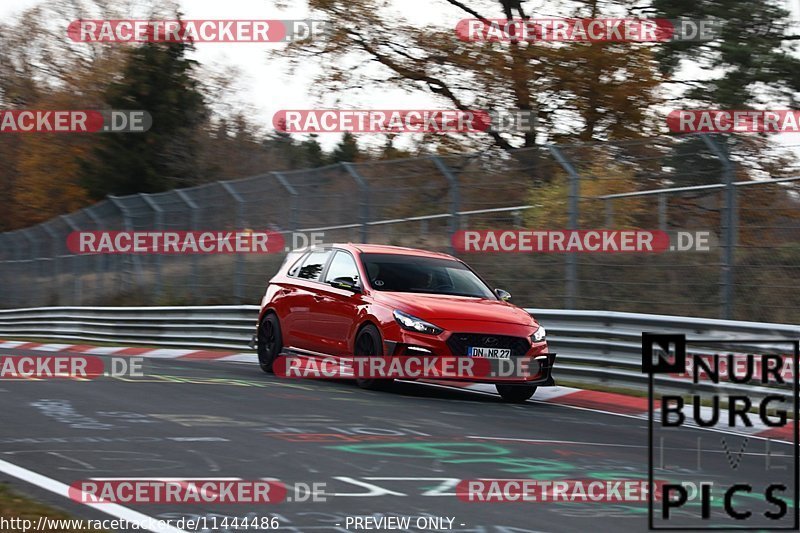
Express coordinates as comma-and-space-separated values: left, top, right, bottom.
373, 291, 538, 327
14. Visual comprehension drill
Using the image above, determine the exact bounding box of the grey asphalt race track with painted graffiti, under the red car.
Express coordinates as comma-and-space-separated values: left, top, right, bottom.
0, 350, 792, 533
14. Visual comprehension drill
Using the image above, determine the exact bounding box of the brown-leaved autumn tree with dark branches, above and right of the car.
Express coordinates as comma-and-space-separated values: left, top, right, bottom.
274, 0, 659, 150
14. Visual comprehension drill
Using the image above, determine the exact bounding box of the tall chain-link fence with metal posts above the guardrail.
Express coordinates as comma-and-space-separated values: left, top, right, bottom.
0, 136, 800, 322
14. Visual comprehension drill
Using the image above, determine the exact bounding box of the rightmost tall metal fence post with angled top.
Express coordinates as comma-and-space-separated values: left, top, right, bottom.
701, 135, 738, 319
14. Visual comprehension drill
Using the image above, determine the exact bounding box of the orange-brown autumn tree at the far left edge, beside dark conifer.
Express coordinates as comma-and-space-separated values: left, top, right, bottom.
0, 1, 134, 229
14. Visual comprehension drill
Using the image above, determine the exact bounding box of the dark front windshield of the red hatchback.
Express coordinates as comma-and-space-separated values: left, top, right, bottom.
361, 254, 496, 300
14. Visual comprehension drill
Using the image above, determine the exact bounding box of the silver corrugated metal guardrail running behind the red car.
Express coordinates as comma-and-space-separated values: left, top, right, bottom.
0, 305, 800, 396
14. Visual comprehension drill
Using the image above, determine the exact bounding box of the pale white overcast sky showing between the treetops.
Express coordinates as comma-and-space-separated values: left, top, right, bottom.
0, 0, 800, 154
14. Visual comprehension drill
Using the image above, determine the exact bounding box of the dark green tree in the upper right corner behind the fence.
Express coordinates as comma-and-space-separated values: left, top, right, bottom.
650, 0, 800, 239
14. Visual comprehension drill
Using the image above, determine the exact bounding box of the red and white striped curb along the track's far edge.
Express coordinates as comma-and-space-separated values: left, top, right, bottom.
0, 340, 794, 443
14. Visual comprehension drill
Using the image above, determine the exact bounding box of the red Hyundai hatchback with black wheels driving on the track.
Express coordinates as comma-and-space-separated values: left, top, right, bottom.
254, 244, 555, 402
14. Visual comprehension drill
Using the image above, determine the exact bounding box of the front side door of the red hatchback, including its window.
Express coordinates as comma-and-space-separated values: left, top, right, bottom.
311, 250, 363, 356
